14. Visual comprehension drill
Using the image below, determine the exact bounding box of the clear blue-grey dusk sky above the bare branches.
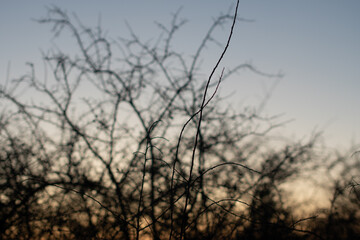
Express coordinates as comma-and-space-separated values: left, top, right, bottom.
0, 0, 360, 148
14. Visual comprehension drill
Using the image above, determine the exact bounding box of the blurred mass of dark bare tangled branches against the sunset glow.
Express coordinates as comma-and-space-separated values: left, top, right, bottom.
0, 1, 360, 240
